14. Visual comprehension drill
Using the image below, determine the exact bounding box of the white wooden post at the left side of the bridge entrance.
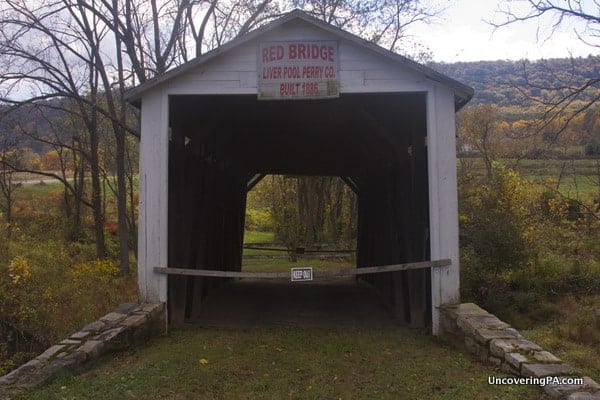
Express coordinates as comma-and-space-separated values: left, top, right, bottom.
138, 90, 169, 302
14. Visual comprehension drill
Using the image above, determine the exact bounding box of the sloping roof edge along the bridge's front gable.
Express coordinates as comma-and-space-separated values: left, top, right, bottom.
125, 9, 474, 110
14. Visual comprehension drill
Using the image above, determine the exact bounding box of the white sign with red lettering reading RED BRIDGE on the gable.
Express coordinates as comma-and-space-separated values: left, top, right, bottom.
258, 40, 340, 100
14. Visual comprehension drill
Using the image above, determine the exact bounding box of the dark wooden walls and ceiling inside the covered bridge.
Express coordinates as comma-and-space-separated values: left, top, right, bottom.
169, 93, 431, 326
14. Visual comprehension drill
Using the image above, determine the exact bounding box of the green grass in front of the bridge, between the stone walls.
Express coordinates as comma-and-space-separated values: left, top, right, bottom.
21, 328, 543, 400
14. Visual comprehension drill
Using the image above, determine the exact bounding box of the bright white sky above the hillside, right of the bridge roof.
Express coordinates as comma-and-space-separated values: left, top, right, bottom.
411, 0, 598, 62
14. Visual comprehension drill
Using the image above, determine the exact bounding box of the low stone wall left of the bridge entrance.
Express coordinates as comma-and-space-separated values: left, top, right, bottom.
0, 303, 166, 392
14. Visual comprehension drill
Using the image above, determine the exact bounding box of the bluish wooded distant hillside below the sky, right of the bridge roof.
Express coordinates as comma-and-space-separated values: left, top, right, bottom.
430, 56, 600, 106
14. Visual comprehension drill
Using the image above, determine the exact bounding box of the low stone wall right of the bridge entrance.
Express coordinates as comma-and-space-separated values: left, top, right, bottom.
440, 303, 600, 400
